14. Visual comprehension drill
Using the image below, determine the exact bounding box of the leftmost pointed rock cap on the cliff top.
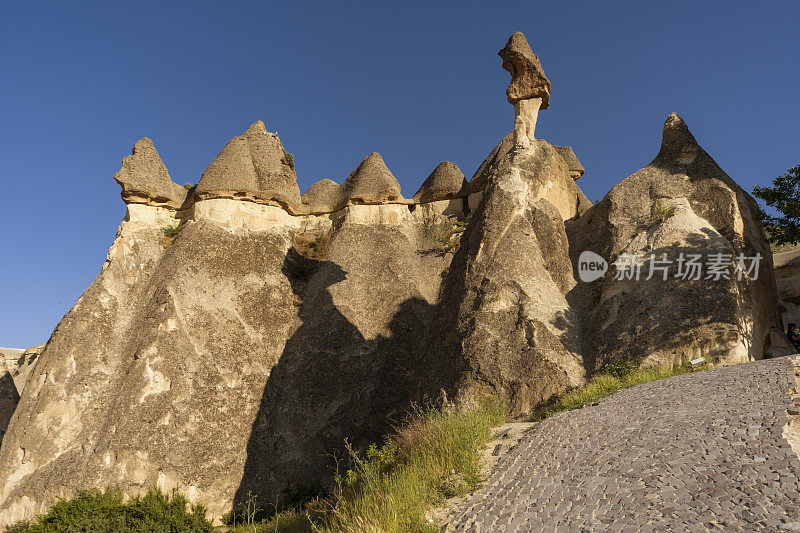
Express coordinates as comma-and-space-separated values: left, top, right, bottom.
114, 137, 188, 209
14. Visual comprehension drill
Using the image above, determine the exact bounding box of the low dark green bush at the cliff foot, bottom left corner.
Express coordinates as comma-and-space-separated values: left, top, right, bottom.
6, 488, 215, 533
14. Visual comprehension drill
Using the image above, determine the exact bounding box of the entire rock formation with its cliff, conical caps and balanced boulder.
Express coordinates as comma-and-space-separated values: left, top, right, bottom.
0, 34, 780, 524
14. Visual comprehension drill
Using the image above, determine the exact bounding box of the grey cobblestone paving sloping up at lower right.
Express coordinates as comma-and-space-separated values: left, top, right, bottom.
448, 358, 800, 532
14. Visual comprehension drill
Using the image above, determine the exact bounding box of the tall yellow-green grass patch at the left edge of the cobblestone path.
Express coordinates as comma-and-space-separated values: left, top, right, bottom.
227, 400, 507, 533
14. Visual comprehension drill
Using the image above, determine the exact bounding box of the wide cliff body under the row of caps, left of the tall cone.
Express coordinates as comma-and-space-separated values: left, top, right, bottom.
0, 181, 456, 524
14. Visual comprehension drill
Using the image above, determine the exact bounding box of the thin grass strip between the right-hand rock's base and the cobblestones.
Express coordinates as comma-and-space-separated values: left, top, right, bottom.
531, 363, 707, 421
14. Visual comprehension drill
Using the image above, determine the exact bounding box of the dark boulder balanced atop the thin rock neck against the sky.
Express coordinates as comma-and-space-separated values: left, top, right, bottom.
497, 31, 550, 109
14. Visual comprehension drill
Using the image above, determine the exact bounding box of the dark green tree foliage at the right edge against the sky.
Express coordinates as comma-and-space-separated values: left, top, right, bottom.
753, 165, 800, 244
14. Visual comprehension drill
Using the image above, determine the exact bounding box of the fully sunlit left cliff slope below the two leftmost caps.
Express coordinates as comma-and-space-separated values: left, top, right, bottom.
0, 209, 300, 524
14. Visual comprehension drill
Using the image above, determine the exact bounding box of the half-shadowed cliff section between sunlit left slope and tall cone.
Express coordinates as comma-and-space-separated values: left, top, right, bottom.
236, 212, 449, 502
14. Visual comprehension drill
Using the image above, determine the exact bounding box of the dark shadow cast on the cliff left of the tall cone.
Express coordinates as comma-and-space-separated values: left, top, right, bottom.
234, 249, 432, 509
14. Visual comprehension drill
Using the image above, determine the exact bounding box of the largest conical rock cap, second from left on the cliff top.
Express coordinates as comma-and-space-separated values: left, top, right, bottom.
196, 120, 301, 213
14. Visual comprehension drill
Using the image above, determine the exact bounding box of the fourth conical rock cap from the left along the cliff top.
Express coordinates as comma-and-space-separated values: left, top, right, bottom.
342, 152, 404, 204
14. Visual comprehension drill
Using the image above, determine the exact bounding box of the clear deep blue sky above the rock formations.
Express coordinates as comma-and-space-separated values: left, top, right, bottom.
0, 0, 800, 347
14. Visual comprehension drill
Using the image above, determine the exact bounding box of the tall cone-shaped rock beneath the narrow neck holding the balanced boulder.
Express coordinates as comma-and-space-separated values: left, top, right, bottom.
419, 141, 585, 415
